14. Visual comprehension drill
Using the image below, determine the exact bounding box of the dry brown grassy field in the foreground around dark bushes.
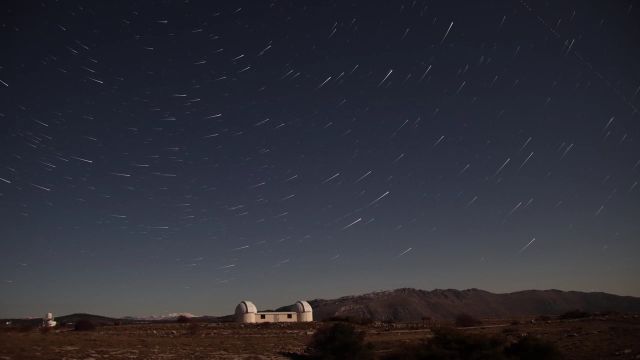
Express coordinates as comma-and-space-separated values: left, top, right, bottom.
0, 316, 640, 360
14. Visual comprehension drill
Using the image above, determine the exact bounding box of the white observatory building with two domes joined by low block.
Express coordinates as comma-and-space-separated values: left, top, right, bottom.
236, 300, 313, 324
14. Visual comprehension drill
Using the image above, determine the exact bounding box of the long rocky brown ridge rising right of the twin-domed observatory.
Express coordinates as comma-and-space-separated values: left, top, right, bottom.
279, 288, 640, 321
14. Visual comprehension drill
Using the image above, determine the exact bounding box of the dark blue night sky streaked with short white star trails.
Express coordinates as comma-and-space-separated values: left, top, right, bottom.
0, 0, 640, 316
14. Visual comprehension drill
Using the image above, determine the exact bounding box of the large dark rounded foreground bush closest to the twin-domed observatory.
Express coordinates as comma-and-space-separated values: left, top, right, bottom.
307, 323, 373, 360
